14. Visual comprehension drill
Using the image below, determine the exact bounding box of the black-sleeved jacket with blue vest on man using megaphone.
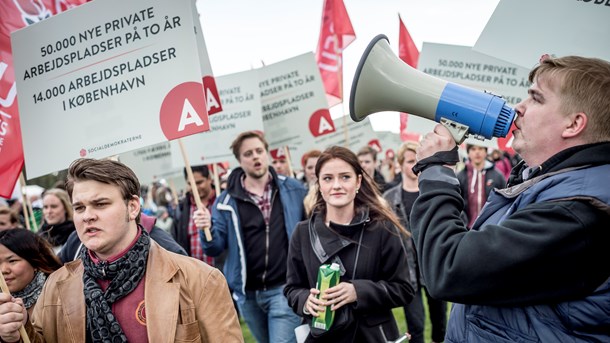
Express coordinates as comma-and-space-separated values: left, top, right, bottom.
411, 143, 610, 342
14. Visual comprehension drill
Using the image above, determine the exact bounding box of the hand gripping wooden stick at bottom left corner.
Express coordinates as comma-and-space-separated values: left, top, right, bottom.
0, 293, 27, 342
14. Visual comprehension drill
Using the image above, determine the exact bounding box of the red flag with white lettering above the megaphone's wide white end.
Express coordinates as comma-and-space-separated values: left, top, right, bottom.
316, 0, 356, 107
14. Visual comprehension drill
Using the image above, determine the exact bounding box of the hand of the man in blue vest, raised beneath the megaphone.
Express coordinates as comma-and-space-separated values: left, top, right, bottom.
413, 124, 459, 175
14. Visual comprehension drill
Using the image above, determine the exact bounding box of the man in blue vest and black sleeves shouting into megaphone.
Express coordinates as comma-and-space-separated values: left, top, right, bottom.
411, 55, 610, 342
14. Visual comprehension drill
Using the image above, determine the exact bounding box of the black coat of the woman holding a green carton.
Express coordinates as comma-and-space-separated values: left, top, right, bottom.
284, 210, 413, 343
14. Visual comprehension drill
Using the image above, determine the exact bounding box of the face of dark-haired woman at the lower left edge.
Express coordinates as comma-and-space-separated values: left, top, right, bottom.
0, 244, 35, 293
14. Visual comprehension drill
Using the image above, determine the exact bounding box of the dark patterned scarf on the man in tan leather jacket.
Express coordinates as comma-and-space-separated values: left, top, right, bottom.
80, 229, 150, 342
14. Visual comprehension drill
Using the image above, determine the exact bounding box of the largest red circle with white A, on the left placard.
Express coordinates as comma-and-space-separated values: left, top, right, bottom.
159, 82, 210, 140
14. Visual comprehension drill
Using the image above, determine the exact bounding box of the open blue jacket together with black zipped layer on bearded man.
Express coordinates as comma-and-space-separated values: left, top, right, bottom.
202, 167, 307, 302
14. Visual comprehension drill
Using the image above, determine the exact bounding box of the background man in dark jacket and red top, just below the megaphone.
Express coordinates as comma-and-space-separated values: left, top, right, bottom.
458, 144, 506, 227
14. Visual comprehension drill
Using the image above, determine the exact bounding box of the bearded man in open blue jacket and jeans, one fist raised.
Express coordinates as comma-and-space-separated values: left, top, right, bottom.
194, 131, 306, 343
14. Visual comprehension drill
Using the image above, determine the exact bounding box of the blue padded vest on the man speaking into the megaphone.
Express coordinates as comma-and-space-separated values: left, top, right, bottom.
446, 165, 610, 342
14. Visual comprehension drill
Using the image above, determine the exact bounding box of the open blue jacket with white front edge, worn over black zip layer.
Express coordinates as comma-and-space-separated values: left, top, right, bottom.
200, 168, 307, 303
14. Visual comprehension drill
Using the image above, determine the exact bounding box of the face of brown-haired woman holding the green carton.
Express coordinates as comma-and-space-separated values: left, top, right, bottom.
318, 158, 362, 209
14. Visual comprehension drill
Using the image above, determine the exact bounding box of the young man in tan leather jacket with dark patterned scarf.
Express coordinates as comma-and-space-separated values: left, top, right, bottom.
0, 159, 243, 343
